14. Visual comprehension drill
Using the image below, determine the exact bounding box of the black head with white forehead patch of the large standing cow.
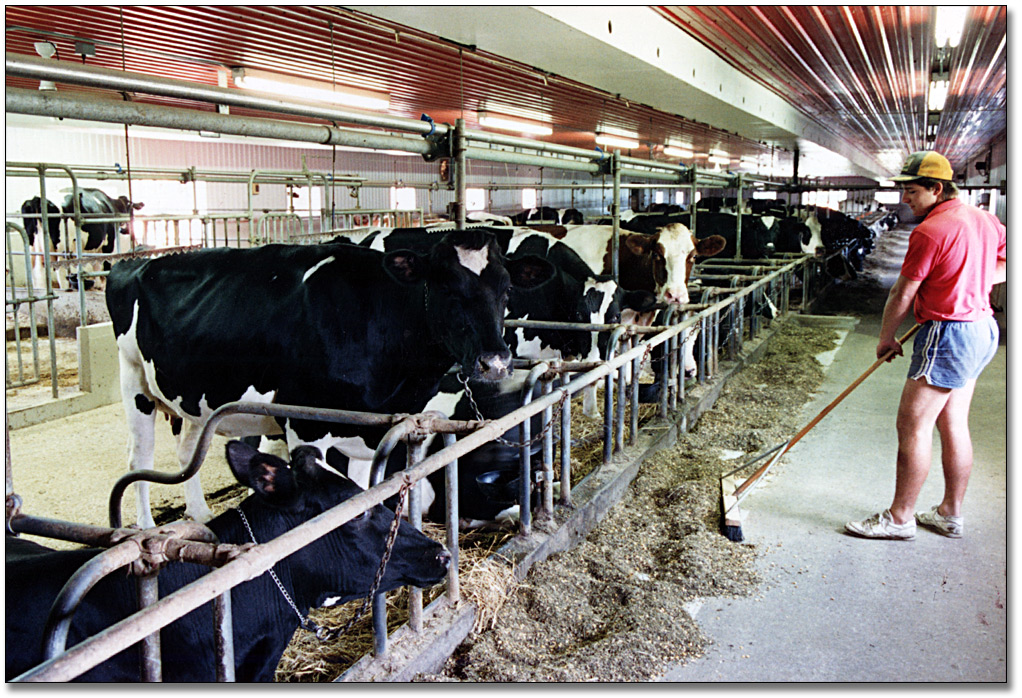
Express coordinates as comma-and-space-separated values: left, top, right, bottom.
384, 230, 523, 380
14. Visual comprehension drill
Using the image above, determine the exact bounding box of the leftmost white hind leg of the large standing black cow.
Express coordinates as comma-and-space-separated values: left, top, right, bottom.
120, 355, 156, 528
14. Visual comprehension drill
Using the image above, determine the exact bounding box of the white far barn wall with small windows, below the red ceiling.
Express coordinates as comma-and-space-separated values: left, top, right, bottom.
5, 123, 628, 223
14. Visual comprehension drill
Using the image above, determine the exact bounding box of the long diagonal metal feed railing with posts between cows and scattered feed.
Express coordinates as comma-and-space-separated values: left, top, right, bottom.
8, 252, 809, 681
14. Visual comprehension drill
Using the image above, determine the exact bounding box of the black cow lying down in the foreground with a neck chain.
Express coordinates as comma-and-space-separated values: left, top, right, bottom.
5, 441, 451, 682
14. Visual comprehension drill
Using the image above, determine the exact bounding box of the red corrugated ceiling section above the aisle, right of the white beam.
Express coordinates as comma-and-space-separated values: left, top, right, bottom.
658, 5, 1008, 171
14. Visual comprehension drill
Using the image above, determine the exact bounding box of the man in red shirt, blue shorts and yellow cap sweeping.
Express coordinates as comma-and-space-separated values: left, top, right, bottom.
845, 150, 1007, 541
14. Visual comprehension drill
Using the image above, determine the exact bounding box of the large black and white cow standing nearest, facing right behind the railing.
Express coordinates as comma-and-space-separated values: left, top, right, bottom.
106, 230, 523, 527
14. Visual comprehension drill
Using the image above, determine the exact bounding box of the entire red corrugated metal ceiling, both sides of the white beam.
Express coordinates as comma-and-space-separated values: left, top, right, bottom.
5, 5, 1007, 179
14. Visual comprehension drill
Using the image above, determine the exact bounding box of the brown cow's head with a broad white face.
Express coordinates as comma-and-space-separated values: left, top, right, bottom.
621, 223, 727, 304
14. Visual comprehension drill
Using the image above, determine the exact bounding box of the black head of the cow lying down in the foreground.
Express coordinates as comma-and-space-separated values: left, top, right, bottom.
225, 440, 451, 608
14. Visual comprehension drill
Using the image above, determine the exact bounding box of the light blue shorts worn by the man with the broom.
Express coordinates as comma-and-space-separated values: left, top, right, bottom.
909, 316, 1001, 389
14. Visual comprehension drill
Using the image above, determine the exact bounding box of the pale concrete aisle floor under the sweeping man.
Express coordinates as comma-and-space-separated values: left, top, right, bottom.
663, 230, 1008, 682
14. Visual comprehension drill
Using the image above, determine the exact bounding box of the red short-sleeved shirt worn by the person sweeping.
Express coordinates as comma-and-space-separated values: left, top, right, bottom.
901, 199, 1007, 323
